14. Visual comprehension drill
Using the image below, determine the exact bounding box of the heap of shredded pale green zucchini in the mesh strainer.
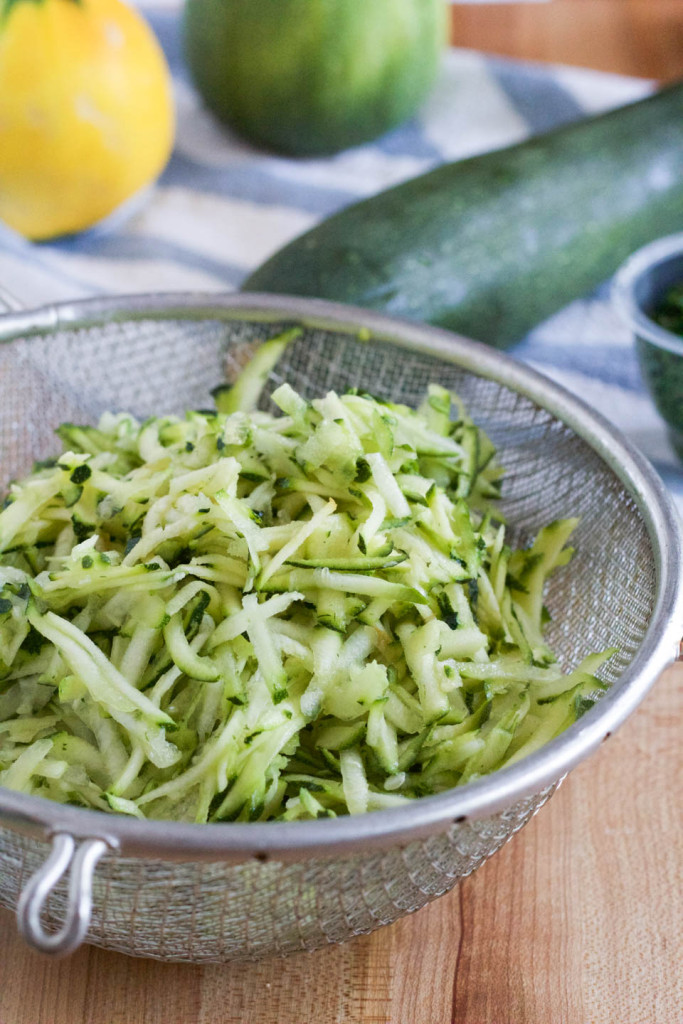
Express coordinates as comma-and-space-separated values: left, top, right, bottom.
0, 333, 612, 822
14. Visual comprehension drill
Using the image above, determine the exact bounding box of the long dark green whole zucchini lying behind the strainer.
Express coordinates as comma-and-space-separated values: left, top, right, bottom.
243, 84, 683, 348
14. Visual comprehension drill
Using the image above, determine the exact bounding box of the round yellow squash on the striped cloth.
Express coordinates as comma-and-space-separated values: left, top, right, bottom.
0, 0, 174, 240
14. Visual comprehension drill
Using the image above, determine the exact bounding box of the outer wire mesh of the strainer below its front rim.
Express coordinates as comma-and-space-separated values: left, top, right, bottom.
0, 791, 551, 963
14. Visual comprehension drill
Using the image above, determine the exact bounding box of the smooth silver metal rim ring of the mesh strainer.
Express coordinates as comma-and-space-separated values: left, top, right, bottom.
0, 292, 683, 861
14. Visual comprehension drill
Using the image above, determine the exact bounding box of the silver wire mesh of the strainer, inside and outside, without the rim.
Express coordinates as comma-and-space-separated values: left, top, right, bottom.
0, 311, 655, 961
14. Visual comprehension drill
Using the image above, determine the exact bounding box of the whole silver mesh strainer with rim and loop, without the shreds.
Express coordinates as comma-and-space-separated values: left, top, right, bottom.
0, 295, 683, 962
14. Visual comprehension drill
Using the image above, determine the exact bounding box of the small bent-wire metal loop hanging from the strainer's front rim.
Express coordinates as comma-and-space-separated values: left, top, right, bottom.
16, 833, 109, 956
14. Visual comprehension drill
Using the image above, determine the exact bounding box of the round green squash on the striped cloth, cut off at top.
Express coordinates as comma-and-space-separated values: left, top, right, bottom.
184, 0, 446, 156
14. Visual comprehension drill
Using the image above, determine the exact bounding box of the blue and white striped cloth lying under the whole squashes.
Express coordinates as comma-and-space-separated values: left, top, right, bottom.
0, 0, 683, 510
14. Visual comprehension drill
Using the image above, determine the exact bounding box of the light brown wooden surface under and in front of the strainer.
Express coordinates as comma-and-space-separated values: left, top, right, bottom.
0, 665, 683, 1024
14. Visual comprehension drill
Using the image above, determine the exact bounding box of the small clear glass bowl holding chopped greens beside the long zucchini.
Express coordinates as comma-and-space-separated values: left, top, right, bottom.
612, 232, 683, 461
